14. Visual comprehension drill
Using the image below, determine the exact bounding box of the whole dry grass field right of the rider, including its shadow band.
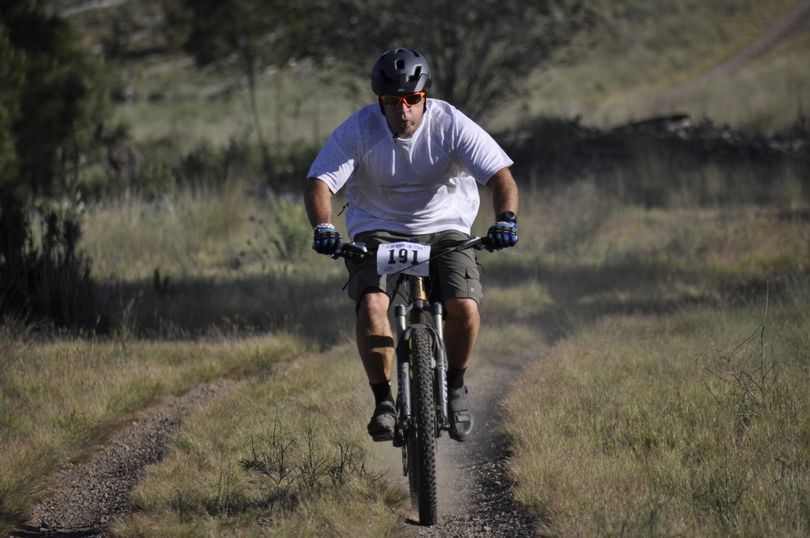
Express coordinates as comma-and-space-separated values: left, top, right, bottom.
497, 183, 810, 536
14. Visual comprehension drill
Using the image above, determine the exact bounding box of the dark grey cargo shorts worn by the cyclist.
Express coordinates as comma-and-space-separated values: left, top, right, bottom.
346, 231, 484, 303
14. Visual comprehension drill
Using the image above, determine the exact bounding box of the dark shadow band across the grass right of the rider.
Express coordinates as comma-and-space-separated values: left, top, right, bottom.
484, 253, 796, 343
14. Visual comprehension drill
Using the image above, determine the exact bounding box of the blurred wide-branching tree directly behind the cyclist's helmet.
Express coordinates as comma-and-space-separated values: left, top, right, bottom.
313, 0, 590, 119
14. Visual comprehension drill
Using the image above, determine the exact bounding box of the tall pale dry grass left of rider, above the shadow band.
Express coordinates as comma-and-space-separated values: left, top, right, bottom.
82, 182, 309, 282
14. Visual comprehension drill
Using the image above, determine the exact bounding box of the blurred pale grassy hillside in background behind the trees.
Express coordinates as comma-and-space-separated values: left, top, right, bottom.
52, 0, 810, 144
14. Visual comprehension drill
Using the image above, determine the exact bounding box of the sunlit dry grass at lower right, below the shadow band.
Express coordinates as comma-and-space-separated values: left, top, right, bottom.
506, 280, 810, 536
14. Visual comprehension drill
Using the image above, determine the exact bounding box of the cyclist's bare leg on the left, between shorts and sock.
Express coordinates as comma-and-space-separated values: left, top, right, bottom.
356, 292, 394, 384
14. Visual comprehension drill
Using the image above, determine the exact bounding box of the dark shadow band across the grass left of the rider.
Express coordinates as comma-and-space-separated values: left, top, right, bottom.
94, 275, 354, 346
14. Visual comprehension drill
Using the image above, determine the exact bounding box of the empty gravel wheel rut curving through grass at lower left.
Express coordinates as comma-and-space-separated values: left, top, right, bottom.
11, 380, 236, 537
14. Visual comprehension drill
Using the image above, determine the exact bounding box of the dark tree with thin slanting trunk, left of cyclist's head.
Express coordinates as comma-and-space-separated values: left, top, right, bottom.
184, 0, 306, 182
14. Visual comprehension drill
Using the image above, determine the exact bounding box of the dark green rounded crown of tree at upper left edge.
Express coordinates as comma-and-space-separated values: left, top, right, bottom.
0, 0, 107, 195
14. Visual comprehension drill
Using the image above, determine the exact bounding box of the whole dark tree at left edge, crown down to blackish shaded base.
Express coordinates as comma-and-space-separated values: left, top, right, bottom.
0, 0, 106, 326
